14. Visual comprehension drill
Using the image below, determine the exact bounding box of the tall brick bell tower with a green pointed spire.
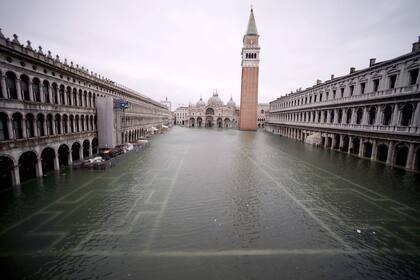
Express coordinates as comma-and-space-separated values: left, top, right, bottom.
239, 7, 260, 130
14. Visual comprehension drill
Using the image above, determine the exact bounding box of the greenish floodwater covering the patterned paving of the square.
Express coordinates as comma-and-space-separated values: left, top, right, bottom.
0, 127, 420, 279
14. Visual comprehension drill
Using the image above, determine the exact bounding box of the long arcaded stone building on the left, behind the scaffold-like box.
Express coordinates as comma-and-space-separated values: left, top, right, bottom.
0, 30, 169, 186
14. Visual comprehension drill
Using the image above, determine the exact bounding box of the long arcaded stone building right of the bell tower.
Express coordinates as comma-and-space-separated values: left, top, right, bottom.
266, 38, 420, 171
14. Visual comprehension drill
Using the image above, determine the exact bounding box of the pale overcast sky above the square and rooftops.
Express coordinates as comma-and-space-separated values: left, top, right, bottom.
0, 0, 420, 107
